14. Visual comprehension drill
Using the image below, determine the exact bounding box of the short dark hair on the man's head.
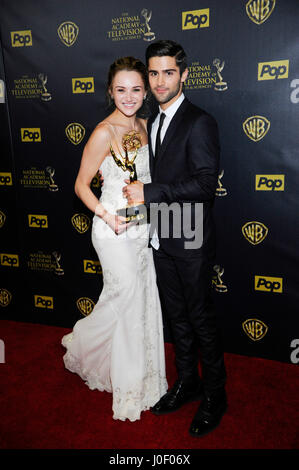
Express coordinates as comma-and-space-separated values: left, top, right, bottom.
145, 39, 187, 75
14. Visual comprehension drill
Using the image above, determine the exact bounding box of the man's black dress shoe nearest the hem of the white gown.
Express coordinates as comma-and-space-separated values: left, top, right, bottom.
151, 380, 203, 415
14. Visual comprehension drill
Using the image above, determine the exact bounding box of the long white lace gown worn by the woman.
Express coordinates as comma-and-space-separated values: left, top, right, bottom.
62, 145, 167, 421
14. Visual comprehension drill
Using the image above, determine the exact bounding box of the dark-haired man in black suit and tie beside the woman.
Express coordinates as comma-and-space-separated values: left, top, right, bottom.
124, 41, 227, 436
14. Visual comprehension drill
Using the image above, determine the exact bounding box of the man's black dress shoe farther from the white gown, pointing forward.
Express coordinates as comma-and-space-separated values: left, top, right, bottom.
189, 390, 227, 437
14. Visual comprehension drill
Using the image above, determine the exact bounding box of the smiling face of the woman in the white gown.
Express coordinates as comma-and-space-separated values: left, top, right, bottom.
110, 70, 145, 117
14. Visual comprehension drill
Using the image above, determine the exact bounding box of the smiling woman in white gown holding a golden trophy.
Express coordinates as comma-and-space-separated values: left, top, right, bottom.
62, 57, 167, 421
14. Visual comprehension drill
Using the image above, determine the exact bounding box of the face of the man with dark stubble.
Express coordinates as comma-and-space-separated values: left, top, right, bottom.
148, 56, 188, 109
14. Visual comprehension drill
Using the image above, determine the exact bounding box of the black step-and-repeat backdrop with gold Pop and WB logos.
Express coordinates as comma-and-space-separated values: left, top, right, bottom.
0, 0, 299, 363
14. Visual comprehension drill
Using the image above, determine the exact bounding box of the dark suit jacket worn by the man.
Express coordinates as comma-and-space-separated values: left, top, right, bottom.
144, 98, 220, 257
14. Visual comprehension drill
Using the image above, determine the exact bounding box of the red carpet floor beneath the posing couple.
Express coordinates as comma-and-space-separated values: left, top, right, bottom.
0, 320, 299, 449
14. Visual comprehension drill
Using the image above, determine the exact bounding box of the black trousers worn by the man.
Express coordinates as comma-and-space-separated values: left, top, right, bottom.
153, 248, 226, 393
